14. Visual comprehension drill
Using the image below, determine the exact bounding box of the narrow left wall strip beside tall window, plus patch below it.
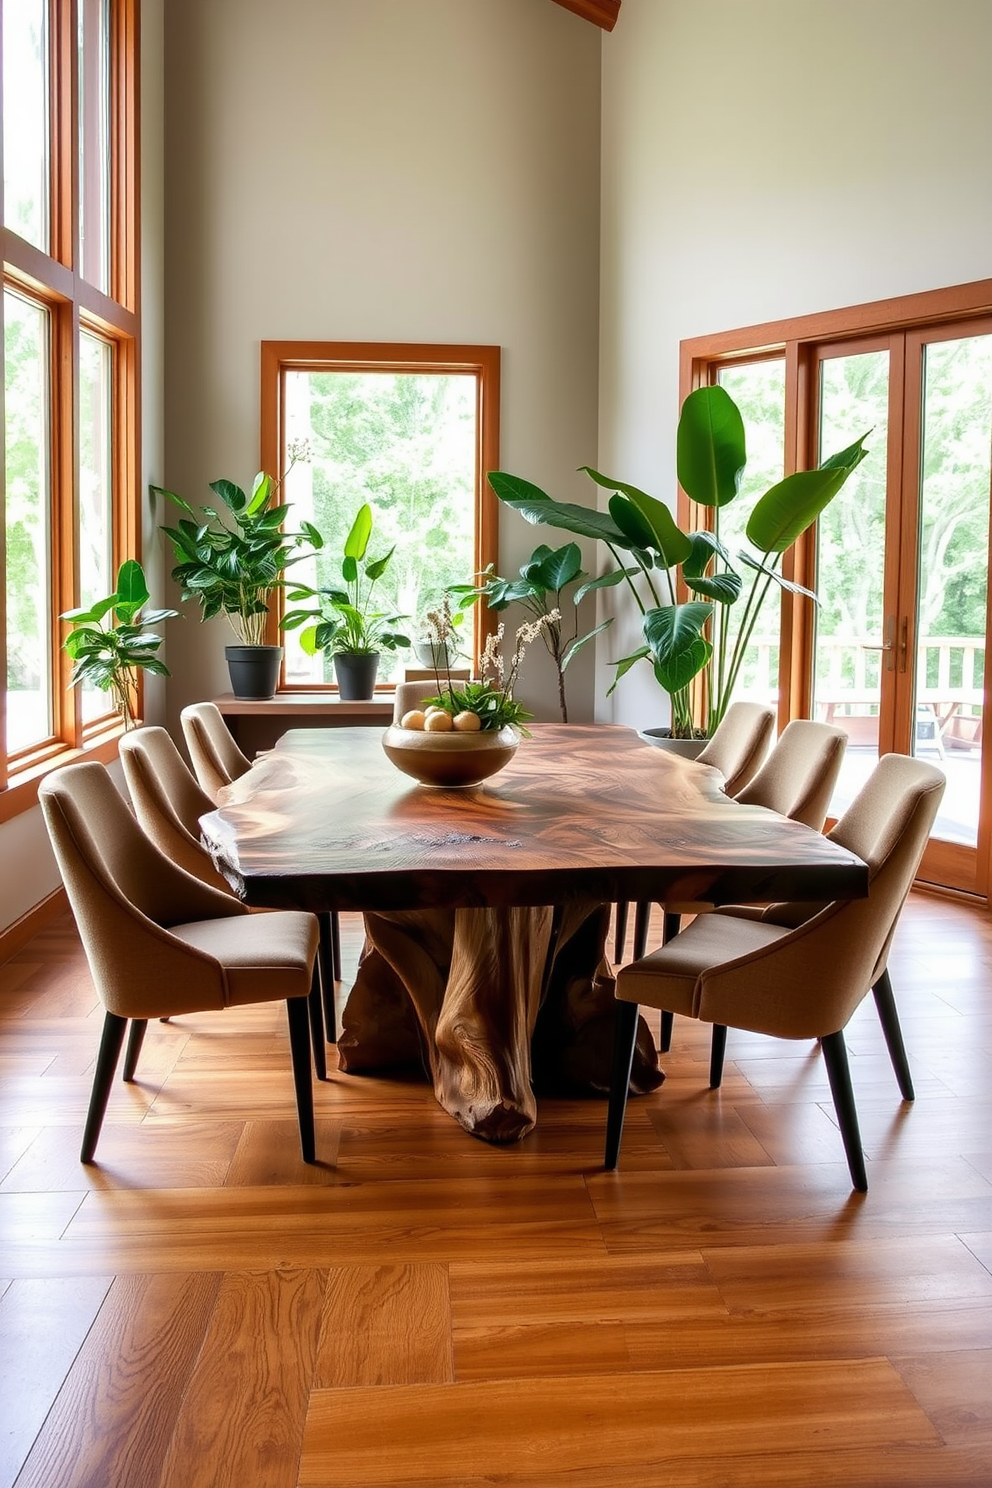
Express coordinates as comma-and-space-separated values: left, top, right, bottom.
0, 0, 165, 931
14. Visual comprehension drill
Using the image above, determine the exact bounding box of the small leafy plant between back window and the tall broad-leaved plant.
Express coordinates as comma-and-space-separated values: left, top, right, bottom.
451, 543, 613, 723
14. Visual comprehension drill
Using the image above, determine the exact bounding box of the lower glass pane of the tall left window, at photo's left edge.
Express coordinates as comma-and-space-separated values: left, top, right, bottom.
3, 292, 54, 753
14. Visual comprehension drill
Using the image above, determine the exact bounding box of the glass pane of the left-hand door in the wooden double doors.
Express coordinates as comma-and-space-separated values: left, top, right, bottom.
814, 351, 895, 815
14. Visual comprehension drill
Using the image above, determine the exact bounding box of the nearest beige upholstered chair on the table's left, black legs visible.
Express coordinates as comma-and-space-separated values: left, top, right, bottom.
39, 762, 318, 1162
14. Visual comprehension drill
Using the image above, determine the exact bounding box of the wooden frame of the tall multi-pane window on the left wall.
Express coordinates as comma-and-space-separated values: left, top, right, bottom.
0, 0, 141, 821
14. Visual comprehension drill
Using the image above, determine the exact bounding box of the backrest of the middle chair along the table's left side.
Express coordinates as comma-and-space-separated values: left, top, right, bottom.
119, 725, 228, 891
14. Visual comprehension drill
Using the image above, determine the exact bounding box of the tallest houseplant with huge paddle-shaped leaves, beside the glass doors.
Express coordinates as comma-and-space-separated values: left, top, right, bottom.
489, 387, 867, 738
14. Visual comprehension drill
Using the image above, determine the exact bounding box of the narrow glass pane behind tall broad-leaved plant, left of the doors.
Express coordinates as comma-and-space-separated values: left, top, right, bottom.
717, 357, 785, 705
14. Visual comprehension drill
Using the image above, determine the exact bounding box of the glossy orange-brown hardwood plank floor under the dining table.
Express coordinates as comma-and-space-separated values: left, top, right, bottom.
0, 894, 992, 1488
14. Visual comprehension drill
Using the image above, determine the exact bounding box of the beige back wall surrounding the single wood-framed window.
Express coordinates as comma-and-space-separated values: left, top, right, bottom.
165, 0, 601, 725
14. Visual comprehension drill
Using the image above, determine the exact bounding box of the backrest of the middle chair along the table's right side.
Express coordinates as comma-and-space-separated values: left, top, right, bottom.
735, 719, 848, 832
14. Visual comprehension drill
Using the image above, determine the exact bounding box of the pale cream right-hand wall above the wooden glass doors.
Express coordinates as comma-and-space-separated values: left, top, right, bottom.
598, 0, 992, 726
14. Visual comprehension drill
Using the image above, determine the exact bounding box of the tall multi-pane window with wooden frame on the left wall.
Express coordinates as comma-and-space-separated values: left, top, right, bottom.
0, 0, 138, 817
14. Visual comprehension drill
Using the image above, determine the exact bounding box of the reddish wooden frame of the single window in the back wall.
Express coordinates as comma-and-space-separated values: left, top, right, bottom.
260, 341, 500, 695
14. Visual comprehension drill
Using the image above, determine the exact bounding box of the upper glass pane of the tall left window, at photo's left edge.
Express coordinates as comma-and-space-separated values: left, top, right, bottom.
3, 0, 49, 253
